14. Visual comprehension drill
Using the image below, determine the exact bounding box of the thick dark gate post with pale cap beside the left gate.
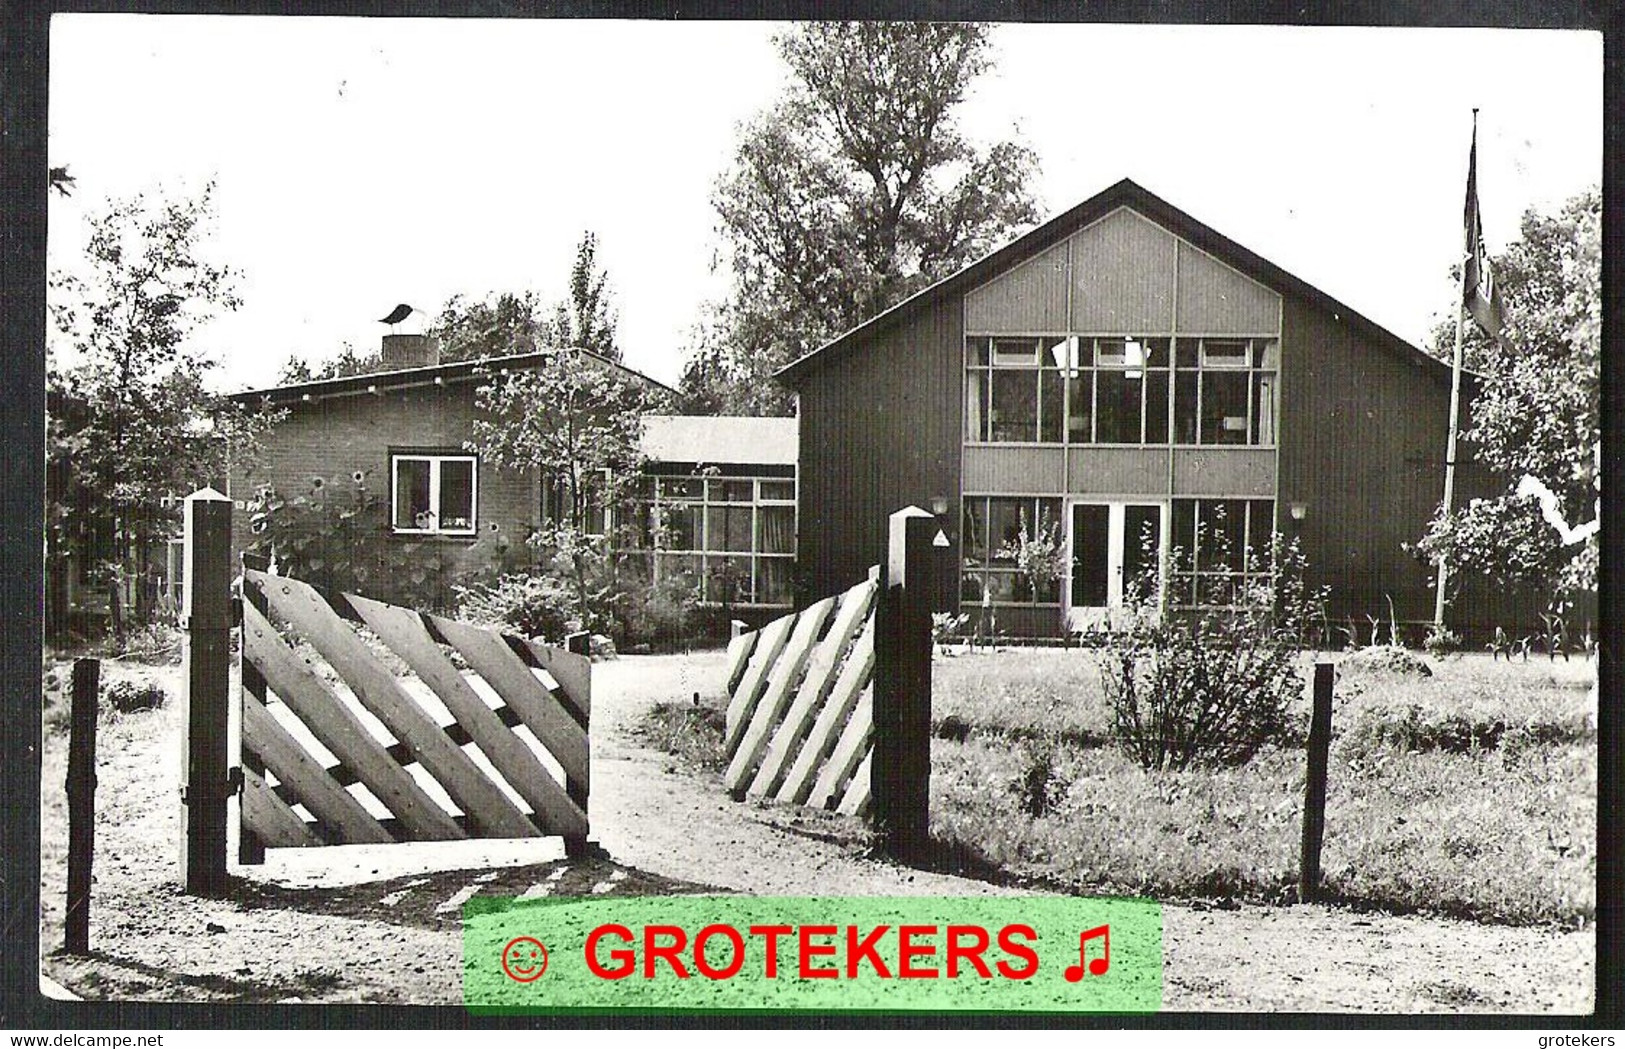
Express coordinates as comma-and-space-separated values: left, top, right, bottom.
180, 489, 232, 896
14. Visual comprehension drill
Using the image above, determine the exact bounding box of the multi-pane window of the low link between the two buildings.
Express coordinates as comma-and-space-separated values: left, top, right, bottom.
640, 477, 796, 604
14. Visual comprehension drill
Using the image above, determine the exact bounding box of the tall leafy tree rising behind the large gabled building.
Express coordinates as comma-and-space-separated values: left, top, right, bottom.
683, 23, 1038, 412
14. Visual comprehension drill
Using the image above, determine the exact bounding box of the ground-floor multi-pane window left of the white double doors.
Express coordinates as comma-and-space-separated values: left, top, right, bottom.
959, 495, 1066, 604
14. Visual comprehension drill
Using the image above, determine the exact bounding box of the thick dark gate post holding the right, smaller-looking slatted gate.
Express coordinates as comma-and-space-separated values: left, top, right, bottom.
869, 507, 938, 859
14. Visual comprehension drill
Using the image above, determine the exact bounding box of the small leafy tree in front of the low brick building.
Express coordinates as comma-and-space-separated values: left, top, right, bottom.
468, 349, 653, 625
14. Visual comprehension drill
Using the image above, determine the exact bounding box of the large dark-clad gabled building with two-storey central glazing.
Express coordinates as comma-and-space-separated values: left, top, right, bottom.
778, 180, 1532, 640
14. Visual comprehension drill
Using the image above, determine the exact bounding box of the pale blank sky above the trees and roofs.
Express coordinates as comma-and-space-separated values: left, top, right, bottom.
49, 15, 1602, 390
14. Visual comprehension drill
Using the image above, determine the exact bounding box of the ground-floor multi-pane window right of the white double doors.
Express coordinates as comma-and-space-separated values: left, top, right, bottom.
1168, 499, 1276, 607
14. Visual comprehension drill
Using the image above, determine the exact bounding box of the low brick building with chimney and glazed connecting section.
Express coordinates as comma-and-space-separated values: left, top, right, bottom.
229, 335, 796, 611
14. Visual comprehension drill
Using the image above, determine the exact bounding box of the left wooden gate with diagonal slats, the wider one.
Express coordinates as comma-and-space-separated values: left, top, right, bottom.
241, 570, 592, 861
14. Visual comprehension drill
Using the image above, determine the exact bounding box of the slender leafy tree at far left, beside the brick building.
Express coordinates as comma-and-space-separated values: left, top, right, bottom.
47, 183, 271, 643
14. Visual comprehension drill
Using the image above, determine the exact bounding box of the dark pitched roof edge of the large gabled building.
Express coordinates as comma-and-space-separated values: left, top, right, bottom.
775, 179, 1450, 386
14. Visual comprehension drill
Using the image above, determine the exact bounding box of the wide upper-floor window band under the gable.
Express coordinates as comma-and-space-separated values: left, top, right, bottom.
965, 335, 1281, 445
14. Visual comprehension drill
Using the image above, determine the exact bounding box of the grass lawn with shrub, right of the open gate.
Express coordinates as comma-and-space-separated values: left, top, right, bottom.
931, 651, 1597, 924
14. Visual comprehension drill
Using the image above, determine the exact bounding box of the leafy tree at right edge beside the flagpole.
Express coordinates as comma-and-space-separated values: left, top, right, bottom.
1419, 190, 1602, 604
